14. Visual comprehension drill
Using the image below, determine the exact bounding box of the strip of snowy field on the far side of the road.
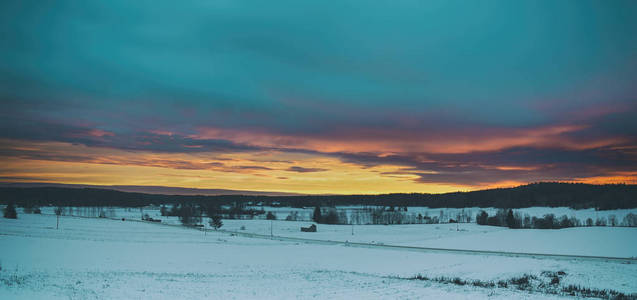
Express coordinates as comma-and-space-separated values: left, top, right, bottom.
215, 220, 637, 257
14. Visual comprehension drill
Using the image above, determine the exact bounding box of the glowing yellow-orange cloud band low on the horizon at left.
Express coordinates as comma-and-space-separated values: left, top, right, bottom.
0, 140, 471, 194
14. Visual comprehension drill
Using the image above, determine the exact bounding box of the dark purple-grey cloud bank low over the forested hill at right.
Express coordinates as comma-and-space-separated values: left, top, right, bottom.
332, 147, 637, 186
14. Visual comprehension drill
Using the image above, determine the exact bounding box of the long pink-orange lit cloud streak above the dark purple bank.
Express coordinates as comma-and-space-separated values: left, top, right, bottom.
190, 125, 623, 155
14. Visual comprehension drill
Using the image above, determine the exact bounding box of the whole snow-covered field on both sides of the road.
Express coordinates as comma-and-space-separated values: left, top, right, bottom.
0, 214, 637, 299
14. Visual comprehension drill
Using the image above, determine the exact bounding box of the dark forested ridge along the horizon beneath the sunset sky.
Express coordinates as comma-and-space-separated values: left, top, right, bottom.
0, 182, 637, 210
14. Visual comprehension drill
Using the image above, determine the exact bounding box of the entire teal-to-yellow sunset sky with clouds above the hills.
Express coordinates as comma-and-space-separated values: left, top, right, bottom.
0, 0, 637, 194
